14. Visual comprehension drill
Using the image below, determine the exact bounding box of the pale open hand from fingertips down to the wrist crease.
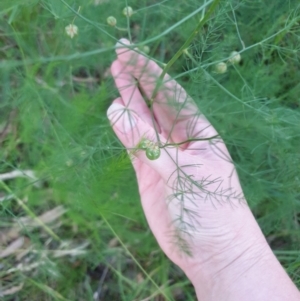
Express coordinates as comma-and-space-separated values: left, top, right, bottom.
108, 39, 264, 275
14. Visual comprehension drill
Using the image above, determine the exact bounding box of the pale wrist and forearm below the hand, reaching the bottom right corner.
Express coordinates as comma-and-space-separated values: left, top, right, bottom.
188, 218, 300, 301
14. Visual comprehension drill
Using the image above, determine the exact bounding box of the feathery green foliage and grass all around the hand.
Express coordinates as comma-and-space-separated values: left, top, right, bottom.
0, 0, 300, 300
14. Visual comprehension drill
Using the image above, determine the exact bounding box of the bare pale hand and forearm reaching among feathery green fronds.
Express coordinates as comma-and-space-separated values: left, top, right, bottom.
107, 39, 300, 300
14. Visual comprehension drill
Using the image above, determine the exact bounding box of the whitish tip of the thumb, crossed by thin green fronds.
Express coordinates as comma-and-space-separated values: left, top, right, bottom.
107, 103, 138, 134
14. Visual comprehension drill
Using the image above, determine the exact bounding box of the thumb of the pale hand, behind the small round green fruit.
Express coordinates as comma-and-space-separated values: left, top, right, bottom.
107, 102, 180, 179
